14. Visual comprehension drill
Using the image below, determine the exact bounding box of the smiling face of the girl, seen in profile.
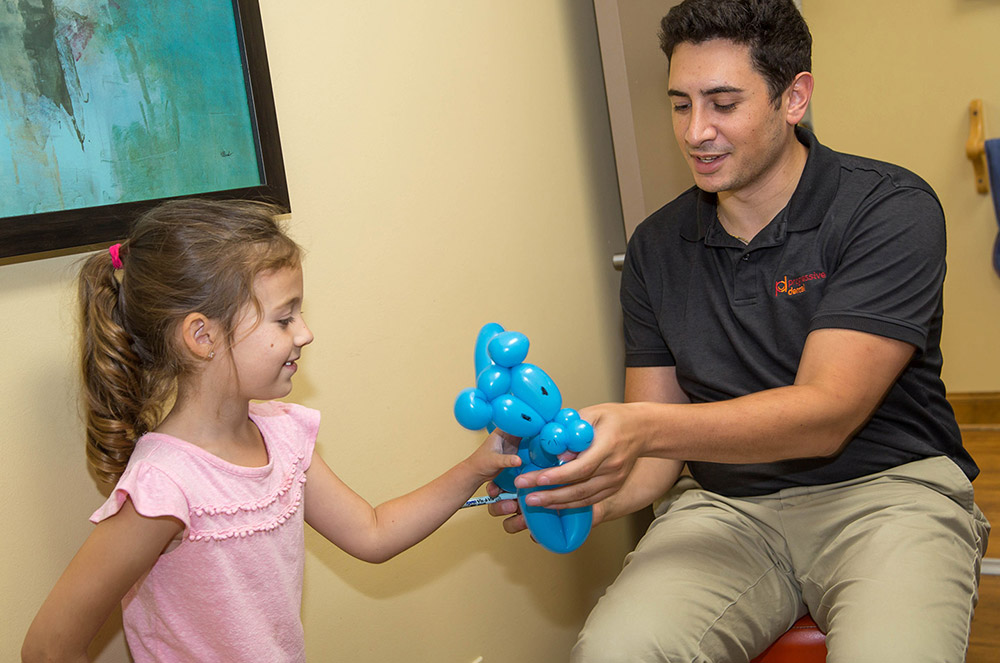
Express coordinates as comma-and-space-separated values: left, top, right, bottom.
232, 267, 313, 400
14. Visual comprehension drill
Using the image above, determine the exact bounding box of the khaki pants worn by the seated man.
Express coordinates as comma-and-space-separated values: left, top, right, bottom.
572, 457, 989, 663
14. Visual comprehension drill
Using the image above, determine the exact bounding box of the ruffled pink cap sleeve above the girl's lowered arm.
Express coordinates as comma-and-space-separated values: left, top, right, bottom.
90, 463, 191, 528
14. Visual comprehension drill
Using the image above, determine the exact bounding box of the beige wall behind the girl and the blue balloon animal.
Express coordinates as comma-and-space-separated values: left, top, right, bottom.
0, 0, 631, 663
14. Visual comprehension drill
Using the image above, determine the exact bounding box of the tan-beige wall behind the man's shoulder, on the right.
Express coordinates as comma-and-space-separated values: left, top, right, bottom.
803, 0, 1000, 392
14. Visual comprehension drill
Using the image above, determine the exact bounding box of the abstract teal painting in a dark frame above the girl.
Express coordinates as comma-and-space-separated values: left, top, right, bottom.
0, 0, 289, 258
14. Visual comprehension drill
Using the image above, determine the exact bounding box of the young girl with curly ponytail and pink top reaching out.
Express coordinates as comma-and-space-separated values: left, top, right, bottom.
22, 200, 520, 663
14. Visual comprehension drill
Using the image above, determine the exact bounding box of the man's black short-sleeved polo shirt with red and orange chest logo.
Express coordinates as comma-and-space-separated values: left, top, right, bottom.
621, 129, 978, 496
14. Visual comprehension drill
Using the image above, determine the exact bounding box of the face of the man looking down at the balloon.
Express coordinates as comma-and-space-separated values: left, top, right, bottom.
668, 39, 790, 194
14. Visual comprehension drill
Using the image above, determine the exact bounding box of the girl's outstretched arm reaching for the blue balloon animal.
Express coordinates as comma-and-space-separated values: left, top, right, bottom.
305, 431, 521, 563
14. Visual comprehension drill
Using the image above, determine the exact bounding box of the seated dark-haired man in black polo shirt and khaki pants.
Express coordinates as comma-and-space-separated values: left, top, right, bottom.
491, 0, 989, 663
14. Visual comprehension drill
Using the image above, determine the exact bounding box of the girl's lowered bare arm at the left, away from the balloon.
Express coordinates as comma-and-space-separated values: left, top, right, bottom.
21, 500, 184, 663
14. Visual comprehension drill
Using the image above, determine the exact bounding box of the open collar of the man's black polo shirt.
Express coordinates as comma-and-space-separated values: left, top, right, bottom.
681, 126, 840, 244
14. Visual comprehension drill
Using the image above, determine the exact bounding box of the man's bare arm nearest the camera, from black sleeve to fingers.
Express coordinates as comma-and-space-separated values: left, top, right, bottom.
515, 329, 914, 508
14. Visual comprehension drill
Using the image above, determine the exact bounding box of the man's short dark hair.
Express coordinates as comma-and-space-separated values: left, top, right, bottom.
660, 0, 812, 102
